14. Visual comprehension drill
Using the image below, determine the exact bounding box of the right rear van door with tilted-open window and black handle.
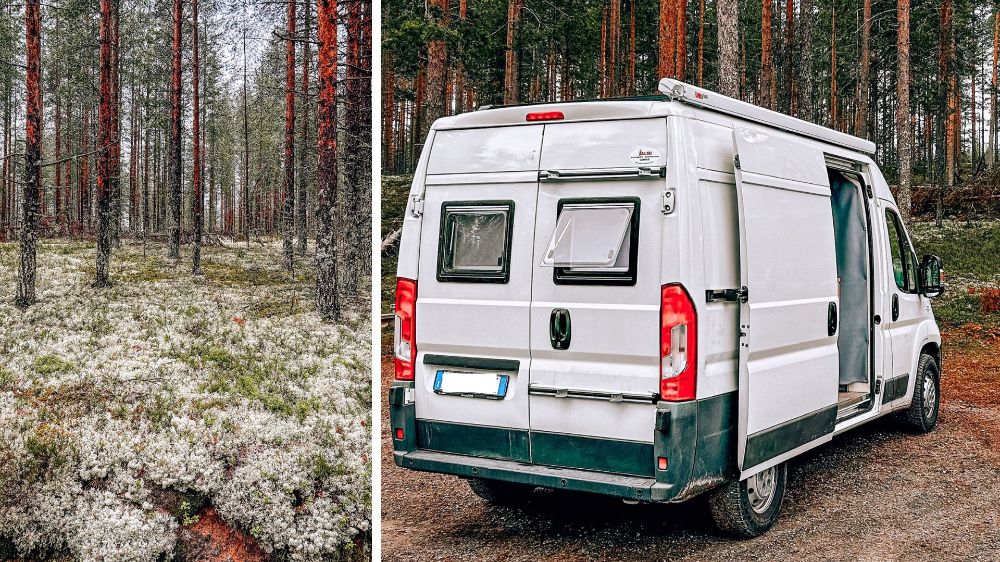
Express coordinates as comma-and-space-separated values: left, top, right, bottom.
529, 118, 667, 476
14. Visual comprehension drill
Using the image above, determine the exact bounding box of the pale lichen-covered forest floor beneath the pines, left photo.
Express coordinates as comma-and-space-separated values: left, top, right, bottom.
0, 240, 372, 561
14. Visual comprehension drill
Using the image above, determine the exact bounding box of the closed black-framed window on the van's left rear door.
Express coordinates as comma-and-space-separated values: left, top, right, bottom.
437, 201, 514, 283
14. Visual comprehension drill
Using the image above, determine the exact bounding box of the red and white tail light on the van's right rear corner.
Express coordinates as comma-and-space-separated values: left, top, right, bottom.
660, 283, 698, 402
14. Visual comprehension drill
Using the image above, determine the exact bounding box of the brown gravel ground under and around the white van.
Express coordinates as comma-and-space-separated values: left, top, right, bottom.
382, 326, 1000, 562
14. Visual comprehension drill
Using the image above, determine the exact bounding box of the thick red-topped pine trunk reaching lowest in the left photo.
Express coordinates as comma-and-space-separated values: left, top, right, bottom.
316, 0, 340, 320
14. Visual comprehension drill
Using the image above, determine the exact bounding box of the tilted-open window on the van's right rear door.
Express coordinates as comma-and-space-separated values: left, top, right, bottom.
540, 197, 639, 285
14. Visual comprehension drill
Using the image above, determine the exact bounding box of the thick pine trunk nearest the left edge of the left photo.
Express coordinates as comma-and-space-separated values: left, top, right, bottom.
14, 0, 42, 307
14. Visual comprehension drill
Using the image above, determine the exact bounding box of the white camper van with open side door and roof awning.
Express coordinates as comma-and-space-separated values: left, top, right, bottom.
389, 79, 943, 537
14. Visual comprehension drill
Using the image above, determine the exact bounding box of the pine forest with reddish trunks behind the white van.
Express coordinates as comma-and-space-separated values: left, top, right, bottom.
382, 0, 1000, 219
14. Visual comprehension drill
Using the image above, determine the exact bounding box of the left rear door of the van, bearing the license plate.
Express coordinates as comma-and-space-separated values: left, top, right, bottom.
414, 125, 542, 462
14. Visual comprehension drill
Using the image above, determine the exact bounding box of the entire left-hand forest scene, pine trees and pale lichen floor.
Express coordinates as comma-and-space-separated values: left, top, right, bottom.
0, 0, 372, 561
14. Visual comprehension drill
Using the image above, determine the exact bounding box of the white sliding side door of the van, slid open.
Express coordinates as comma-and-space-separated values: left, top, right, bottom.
733, 128, 839, 479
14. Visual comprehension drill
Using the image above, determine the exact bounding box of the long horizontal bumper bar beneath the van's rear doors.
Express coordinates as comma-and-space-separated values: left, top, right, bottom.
393, 449, 675, 502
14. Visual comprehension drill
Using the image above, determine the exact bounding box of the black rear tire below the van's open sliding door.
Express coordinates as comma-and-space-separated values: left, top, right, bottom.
708, 463, 788, 539
